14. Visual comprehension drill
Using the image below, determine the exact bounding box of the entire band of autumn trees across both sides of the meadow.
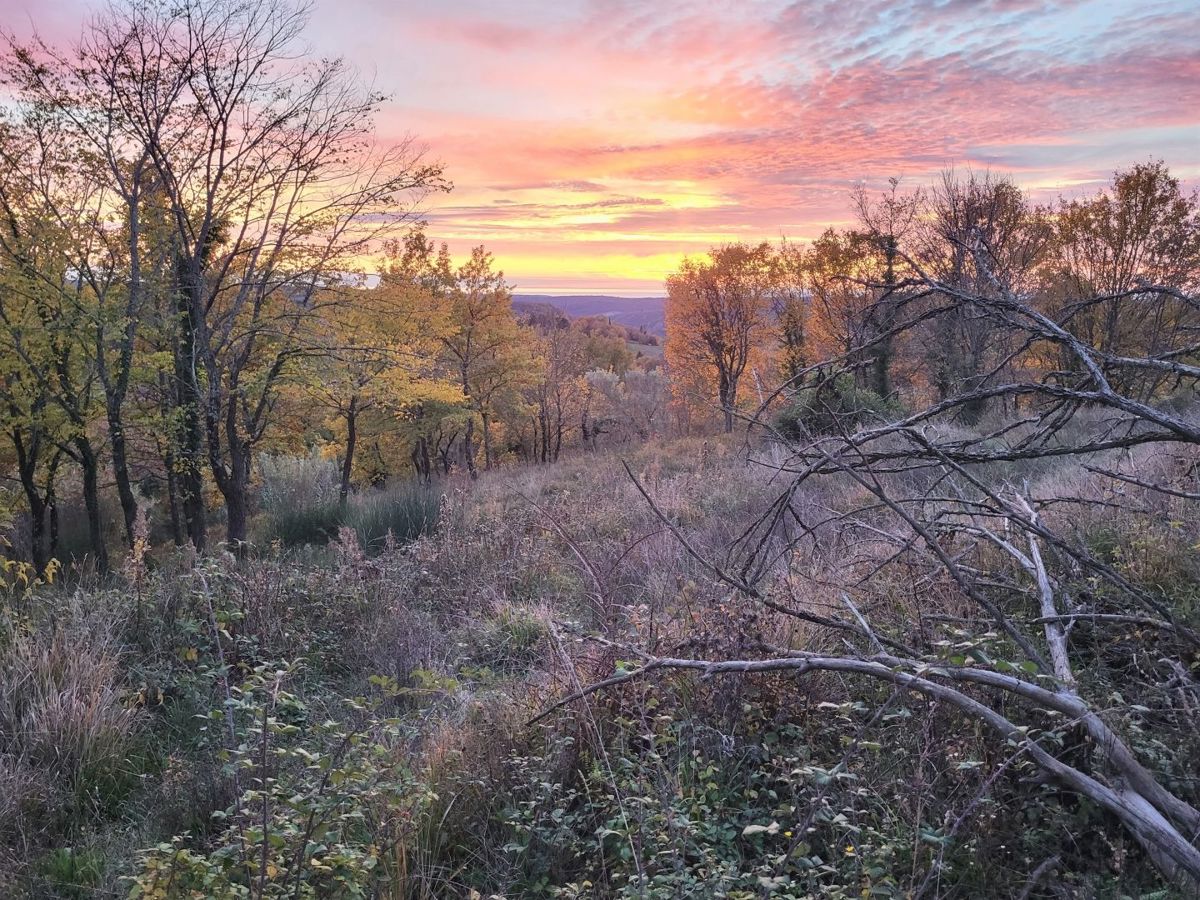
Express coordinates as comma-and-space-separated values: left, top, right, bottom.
0, 0, 1200, 585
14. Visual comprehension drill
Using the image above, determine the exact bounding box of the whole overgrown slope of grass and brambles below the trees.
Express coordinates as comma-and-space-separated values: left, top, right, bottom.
0, 440, 1200, 898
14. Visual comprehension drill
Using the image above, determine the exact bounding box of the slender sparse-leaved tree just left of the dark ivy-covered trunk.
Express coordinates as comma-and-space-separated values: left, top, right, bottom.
2, 10, 187, 542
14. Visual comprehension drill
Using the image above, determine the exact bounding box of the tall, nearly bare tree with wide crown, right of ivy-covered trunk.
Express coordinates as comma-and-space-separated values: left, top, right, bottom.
112, 0, 442, 544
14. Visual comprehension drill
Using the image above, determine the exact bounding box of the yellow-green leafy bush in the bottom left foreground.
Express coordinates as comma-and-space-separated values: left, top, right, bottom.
130, 665, 432, 900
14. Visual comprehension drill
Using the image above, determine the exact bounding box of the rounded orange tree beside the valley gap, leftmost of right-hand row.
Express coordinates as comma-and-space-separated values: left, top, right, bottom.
666, 244, 775, 432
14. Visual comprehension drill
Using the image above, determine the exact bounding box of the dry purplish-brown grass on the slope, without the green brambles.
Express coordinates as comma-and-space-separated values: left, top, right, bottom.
0, 427, 1200, 896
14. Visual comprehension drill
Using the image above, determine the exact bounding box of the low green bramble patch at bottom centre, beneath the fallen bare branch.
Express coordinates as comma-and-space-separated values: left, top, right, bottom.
496, 714, 911, 900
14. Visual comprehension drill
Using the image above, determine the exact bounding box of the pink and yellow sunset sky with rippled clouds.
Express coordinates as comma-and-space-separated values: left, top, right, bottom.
0, 0, 1200, 295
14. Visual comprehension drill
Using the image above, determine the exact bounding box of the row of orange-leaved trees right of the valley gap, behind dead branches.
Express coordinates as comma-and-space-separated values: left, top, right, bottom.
666, 162, 1200, 431
